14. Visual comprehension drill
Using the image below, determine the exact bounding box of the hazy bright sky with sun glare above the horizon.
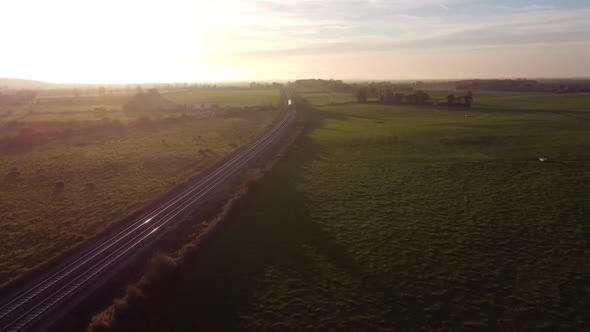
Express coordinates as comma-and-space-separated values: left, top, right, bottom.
0, 0, 590, 83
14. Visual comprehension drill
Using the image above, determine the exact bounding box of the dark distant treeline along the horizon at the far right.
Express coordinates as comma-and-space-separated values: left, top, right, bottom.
455, 79, 590, 93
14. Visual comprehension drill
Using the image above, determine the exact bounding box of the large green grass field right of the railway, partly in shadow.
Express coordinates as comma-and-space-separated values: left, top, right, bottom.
104, 93, 590, 331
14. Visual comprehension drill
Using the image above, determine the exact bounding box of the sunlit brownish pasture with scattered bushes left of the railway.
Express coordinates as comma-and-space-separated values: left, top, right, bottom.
0, 89, 279, 284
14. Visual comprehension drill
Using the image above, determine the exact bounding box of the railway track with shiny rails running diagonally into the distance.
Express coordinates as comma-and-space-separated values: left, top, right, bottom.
0, 104, 296, 332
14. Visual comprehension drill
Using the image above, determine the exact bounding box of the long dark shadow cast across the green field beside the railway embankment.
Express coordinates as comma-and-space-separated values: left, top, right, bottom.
125, 103, 410, 331
